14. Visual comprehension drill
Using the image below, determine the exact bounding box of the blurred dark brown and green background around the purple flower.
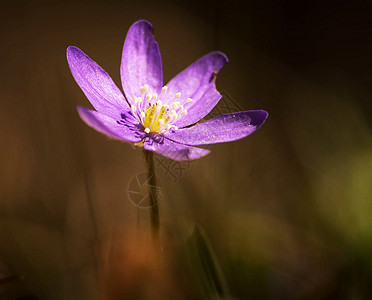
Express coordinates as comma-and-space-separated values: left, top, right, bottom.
0, 0, 372, 299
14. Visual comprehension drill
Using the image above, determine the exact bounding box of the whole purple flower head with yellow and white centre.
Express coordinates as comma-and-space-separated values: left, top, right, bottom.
67, 20, 267, 161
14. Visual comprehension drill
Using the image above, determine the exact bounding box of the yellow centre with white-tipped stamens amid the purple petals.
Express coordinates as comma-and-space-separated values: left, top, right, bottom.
131, 84, 192, 133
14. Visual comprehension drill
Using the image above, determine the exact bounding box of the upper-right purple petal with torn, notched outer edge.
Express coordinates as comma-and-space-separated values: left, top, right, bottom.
161, 52, 228, 127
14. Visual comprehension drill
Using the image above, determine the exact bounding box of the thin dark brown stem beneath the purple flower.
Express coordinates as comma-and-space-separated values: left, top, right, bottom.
143, 150, 160, 244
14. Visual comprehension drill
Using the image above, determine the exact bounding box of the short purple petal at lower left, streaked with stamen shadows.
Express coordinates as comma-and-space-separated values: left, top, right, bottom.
78, 106, 145, 143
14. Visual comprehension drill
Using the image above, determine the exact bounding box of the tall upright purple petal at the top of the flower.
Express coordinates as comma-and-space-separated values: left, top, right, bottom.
120, 20, 163, 103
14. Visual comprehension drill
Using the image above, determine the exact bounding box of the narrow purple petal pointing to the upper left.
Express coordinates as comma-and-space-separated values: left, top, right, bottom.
67, 46, 128, 117
